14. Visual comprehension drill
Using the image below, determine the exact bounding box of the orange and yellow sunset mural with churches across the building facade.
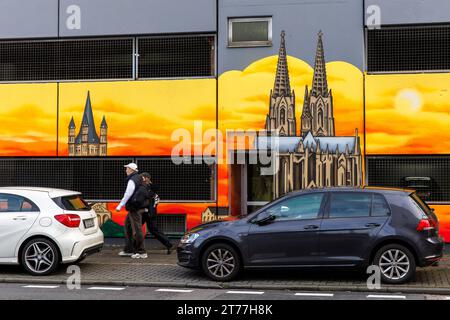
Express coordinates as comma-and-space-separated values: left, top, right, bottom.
0, 35, 450, 241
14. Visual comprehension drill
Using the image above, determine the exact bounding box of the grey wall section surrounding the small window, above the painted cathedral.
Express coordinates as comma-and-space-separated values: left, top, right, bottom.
219, 0, 364, 73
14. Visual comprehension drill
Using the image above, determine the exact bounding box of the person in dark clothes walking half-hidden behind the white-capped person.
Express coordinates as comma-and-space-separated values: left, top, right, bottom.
141, 172, 173, 254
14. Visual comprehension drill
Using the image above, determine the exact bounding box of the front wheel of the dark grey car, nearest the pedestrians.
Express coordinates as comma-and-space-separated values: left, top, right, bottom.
202, 243, 241, 281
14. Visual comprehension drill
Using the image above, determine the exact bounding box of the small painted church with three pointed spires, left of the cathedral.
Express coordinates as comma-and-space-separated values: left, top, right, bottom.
67, 91, 108, 157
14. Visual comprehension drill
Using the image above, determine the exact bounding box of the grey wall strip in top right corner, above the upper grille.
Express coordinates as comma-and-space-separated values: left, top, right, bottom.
365, 0, 450, 25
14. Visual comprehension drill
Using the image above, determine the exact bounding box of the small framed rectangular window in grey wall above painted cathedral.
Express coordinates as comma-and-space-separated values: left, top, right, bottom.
228, 17, 272, 47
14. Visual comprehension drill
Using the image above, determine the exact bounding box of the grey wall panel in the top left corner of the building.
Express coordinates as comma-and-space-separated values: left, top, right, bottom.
0, 0, 58, 39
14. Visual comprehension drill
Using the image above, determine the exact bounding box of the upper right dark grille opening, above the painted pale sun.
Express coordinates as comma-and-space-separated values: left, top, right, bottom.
367, 25, 450, 72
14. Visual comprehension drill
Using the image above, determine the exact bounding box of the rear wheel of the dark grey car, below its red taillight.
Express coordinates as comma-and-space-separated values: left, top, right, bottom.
374, 244, 416, 284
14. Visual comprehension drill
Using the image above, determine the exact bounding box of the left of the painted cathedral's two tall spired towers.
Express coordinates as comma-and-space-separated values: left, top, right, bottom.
266, 31, 297, 136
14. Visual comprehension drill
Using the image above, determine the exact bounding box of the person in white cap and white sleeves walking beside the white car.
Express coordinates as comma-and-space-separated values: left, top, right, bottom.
116, 163, 147, 259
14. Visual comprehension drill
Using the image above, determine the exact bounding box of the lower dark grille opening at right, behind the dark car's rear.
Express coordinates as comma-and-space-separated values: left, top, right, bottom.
366, 155, 450, 202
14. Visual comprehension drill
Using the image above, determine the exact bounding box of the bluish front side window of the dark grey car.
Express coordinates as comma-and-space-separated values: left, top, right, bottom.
267, 193, 323, 221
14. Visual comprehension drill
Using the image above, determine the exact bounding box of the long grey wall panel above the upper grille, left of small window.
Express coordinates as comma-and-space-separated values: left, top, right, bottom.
60, 0, 216, 37
